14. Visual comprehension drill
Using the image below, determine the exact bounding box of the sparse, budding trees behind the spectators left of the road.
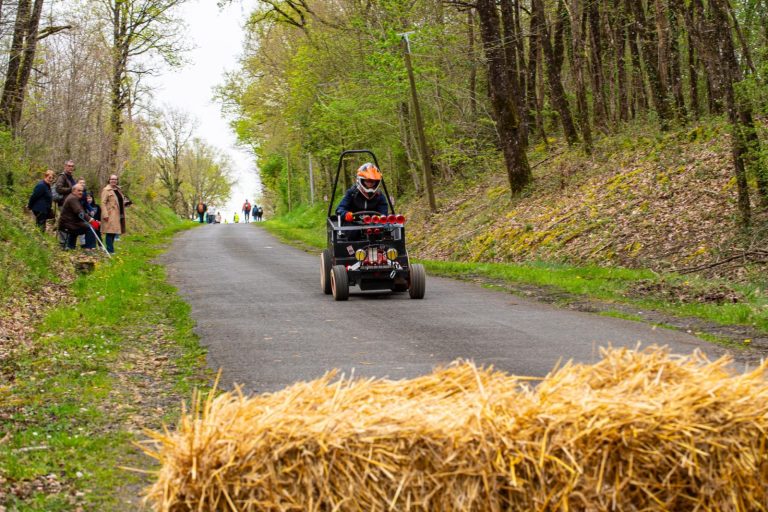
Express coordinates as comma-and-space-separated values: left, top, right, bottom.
0, 0, 232, 215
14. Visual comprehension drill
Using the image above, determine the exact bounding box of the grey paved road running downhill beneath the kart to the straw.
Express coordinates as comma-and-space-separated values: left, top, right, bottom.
162, 224, 714, 392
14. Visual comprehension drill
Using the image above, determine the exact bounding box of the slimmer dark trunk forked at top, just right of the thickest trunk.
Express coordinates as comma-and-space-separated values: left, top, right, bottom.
531, 0, 579, 146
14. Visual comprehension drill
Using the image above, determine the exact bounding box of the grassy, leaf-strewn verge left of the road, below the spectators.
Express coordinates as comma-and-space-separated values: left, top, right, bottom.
0, 215, 210, 511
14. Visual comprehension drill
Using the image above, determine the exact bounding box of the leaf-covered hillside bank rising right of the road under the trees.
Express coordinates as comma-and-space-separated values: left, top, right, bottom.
402, 121, 768, 278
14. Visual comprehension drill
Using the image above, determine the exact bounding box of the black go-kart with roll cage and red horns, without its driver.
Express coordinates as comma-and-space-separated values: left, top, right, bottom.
320, 149, 427, 300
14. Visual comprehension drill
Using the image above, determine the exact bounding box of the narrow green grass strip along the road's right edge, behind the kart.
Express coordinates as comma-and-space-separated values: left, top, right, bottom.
264, 206, 768, 332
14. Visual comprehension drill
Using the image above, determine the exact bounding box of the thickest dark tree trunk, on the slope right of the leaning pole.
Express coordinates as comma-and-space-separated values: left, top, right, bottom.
477, 0, 531, 194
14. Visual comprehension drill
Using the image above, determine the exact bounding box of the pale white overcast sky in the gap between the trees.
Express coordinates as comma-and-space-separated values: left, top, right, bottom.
147, 0, 260, 218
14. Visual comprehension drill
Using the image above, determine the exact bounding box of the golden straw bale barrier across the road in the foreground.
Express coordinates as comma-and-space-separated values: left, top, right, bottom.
147, 348, 768, 512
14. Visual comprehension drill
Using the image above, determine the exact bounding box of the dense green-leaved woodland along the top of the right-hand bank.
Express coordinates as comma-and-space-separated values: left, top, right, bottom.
220, 0, 768, 225
